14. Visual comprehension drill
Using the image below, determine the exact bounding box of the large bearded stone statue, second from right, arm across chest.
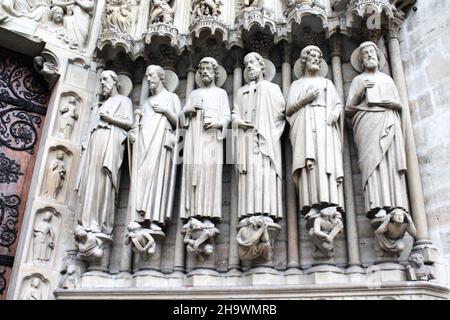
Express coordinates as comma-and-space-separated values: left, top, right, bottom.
286, 46, 344, 216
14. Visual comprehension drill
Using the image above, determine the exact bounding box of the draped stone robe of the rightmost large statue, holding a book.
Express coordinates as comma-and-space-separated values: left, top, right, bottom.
346, 71, 409, 212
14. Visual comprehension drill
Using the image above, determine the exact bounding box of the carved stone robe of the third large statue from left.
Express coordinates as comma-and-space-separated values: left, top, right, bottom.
180, 87, 230, 218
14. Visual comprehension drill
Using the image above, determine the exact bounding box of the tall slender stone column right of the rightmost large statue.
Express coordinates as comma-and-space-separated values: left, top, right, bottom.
387, 21, 437, 262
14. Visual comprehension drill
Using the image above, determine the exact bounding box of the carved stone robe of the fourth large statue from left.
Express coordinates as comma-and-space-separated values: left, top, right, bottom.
232, 80, 286, 218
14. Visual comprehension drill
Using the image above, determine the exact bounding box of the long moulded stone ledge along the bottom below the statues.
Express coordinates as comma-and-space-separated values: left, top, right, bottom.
54, 282, 449, 300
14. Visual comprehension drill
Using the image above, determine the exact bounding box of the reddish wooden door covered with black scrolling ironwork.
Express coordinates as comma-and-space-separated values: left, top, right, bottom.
0, 48, 50, 299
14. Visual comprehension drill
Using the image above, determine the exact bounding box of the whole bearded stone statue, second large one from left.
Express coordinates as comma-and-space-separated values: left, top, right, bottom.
129, 65, 181, 230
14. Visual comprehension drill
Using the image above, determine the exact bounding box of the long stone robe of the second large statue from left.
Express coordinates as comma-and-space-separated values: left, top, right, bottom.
136, 90, 181, 224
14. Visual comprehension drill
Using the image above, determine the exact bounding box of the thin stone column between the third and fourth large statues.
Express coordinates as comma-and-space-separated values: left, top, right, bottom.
227, 48, 243, 271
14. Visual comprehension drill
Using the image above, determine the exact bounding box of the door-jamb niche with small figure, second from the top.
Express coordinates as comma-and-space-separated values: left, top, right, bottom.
40, 146, 73, 202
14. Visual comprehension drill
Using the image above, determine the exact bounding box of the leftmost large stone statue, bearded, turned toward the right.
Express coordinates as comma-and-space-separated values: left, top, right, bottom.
76, 70, 133, 235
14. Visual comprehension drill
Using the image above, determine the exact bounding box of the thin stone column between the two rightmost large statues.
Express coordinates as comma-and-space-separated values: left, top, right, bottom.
331, 34, 361, 266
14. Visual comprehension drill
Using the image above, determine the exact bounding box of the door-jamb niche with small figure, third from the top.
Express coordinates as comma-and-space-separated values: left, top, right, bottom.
29, 207, 61, 264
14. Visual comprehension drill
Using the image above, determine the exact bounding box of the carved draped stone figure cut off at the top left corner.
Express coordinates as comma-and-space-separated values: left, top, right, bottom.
0, 0, 50, 23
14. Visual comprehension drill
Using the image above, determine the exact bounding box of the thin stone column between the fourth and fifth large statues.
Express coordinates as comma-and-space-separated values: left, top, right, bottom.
281, 42, 300, 268
